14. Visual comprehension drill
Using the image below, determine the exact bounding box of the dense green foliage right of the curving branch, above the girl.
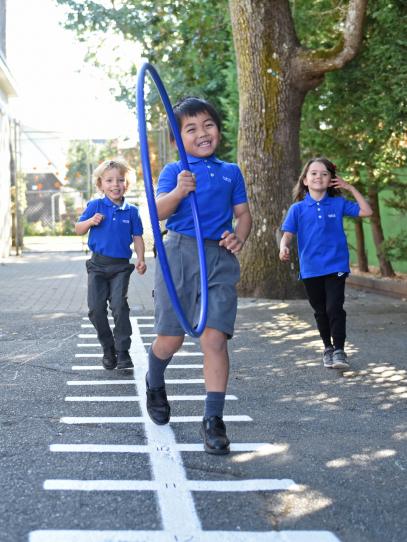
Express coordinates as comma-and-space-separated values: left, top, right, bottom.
301, 0, 407, 190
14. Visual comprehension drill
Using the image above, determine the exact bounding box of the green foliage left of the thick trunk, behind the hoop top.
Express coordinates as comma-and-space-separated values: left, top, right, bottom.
57, 0, 238, 158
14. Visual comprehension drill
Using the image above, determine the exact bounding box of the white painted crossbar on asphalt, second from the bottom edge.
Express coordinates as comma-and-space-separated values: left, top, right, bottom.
43, 478, 298, 492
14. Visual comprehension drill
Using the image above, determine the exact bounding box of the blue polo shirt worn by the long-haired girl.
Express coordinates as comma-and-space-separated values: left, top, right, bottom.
281, 193, 360, 279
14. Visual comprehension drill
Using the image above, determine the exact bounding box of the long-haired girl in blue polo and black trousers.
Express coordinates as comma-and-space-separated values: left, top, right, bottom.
280, 157, 372, 369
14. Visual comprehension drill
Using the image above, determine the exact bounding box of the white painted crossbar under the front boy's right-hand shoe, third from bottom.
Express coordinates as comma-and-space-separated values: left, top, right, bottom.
49, 442, 273, 454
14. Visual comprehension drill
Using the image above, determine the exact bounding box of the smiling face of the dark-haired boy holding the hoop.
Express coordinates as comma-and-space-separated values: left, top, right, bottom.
181, 112, 220, 158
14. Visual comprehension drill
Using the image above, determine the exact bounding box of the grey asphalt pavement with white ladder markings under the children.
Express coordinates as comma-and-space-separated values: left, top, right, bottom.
0, 246, 407, 542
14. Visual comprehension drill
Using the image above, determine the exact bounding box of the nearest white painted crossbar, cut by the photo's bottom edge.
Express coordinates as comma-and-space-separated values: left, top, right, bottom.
29, 530, 340, 542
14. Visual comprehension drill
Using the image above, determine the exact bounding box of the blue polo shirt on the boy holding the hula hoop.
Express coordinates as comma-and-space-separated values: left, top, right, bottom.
157, 155, 247, 240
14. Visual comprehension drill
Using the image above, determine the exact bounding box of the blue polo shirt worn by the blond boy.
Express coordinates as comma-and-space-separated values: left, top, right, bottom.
78, 196, 143, 259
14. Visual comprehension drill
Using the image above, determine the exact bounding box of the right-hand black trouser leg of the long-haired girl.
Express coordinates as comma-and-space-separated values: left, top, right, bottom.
325, 275, 346, 350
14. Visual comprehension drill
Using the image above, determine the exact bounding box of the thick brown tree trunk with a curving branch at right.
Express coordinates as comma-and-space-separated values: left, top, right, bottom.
229, 0, 367, 298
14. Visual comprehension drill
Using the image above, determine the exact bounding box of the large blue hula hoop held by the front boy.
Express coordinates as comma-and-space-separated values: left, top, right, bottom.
136, 62, 208, 337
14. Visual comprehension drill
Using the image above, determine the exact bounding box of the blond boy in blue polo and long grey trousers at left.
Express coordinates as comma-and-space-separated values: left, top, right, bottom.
75, 158, 146, 369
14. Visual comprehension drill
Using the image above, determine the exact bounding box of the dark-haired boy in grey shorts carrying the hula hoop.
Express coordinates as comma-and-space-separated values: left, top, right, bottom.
146, 97, 252, 455
